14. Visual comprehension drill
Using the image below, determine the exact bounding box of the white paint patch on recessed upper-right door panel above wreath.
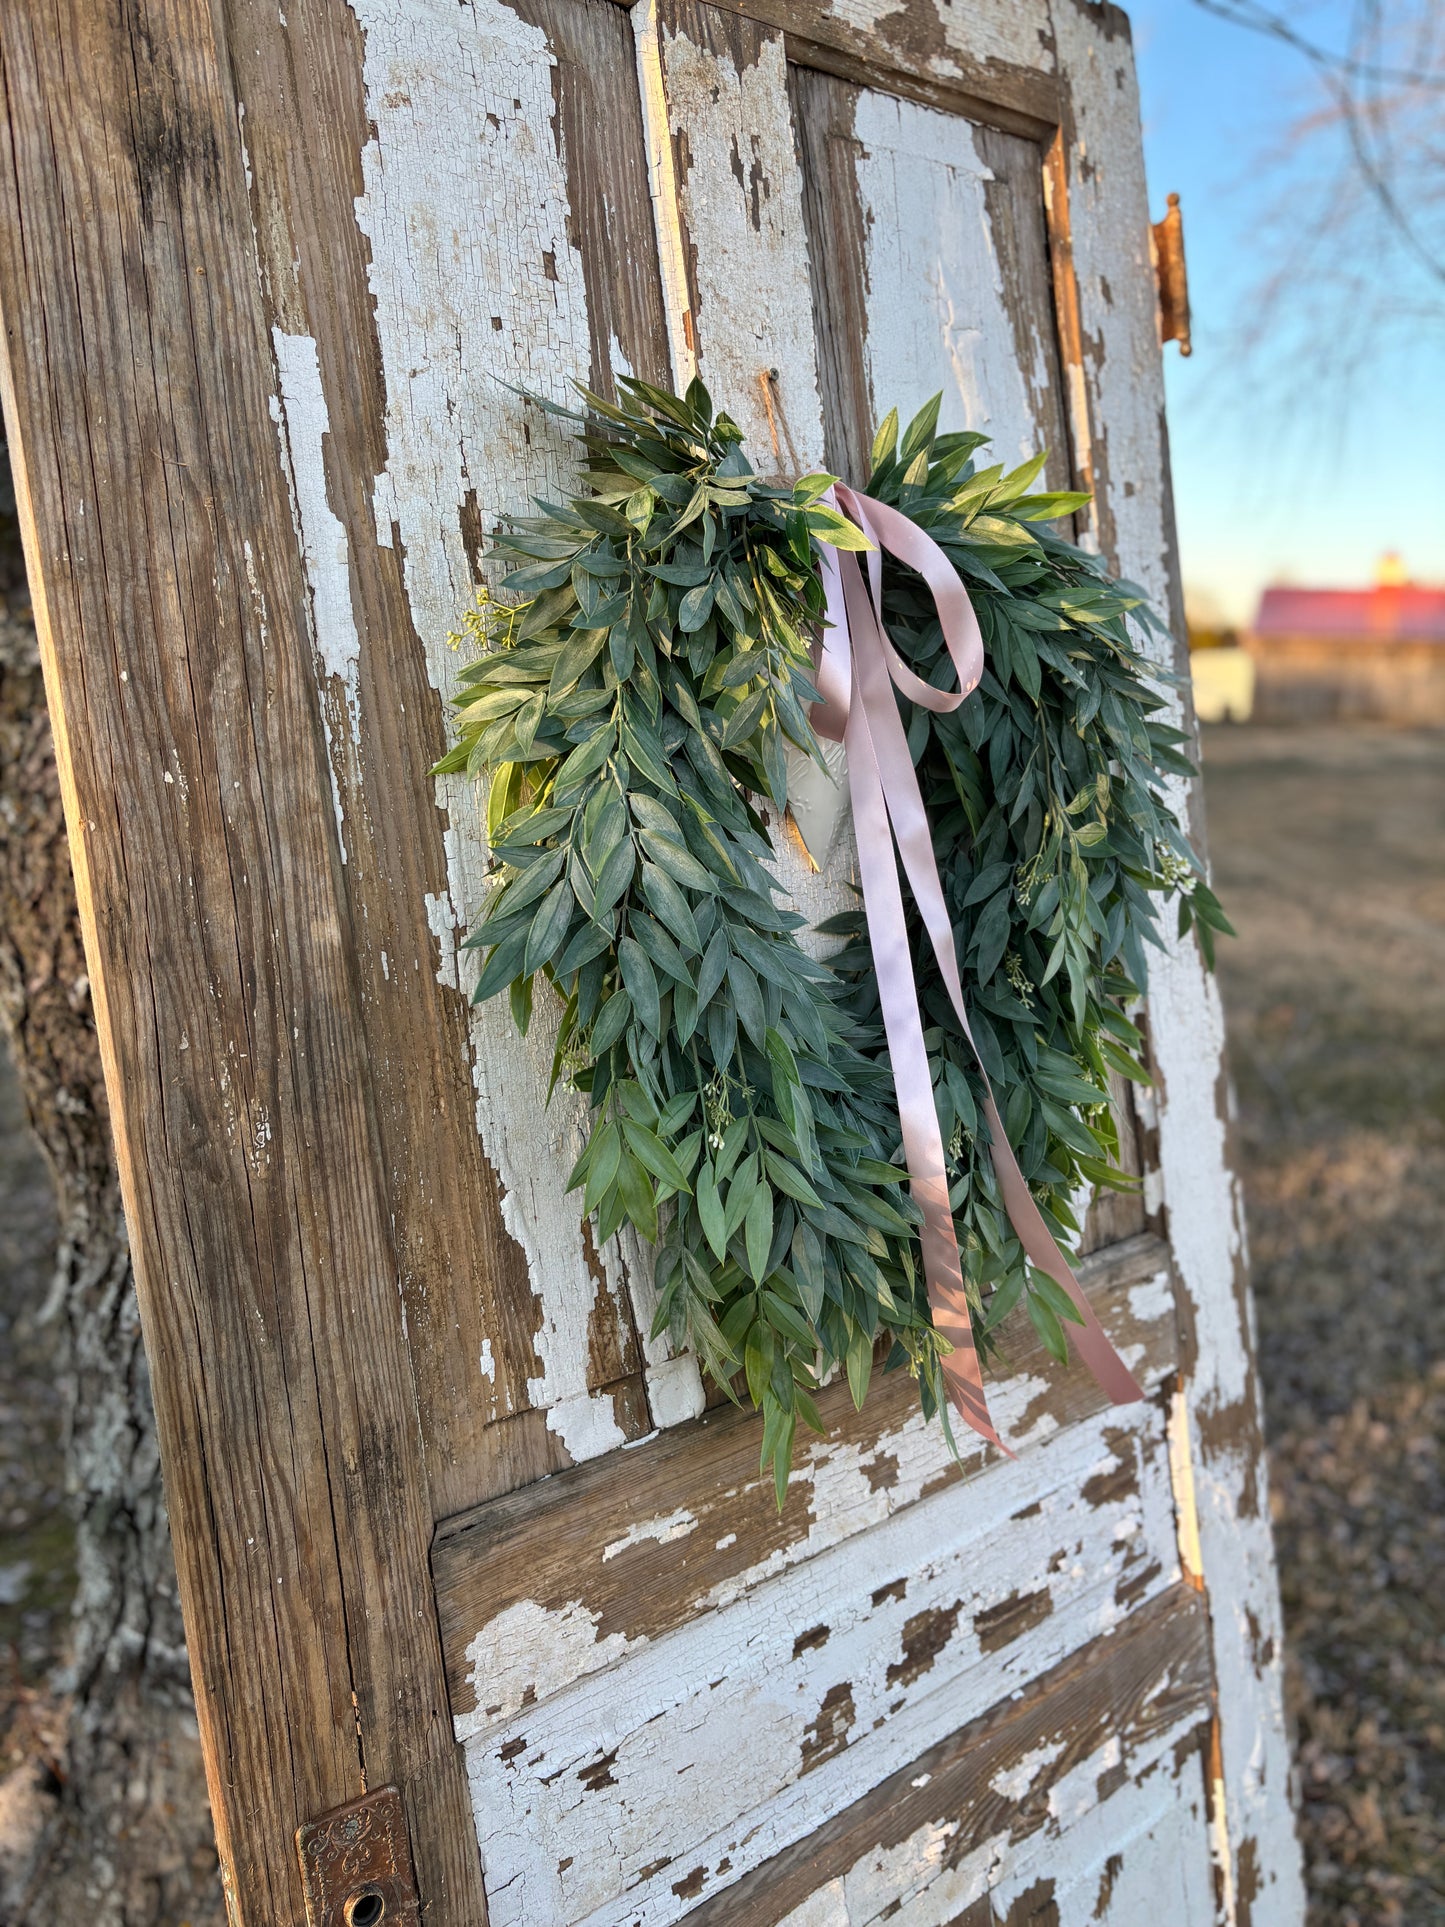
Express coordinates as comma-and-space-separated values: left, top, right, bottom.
854, 89, 1048, 466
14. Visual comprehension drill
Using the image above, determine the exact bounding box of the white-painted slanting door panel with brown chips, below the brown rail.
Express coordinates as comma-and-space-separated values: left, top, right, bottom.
466, 1407, 1179, 1927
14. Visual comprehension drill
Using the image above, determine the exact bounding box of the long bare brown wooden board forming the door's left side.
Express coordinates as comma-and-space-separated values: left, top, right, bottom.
0, 0, 486, 1927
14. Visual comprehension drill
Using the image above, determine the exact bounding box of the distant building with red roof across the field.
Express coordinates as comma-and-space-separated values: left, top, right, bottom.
1245, 555, 1445, 725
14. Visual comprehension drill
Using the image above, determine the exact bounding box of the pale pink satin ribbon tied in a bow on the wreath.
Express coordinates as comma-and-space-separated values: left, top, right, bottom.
813, 482, 1144, 1451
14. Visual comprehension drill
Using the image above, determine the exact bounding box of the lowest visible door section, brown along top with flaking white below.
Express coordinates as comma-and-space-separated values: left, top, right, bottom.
688, 1586, 1212, 1927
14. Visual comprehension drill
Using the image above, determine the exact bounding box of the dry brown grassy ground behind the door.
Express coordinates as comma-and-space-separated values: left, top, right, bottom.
0, 728, 1445, 1927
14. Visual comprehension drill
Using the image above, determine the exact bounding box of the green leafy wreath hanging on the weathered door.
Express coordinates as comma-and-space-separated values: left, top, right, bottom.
437, 380, 1227, 1503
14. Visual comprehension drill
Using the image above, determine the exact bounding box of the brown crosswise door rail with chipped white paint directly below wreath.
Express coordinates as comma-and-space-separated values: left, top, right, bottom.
432, 1237, 1177, 1736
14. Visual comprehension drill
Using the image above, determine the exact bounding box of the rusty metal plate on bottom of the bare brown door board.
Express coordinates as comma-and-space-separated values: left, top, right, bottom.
297, 1786, 422, 1927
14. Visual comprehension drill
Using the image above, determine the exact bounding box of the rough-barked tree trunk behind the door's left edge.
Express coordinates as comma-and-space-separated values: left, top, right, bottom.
0, 447, 223, 1927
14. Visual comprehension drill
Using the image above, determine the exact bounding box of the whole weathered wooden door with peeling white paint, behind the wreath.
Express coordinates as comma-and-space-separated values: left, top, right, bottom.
0, 0, 1301, 1927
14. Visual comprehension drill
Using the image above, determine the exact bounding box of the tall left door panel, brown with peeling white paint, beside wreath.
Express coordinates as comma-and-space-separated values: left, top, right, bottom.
223, 0, 697, 1513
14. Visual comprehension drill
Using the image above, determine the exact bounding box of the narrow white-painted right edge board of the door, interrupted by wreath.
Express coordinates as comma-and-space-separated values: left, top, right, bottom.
1054, 0, 1304, 1927
